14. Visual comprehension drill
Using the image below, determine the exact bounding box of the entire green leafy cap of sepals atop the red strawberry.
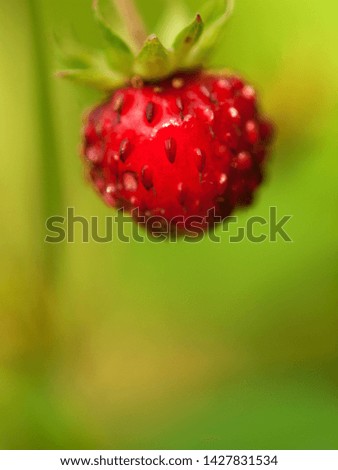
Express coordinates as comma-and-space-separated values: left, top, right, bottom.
58, 0, 235, 92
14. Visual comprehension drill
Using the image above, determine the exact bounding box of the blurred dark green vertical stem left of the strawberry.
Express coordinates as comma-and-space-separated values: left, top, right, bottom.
28, 0, 64, 283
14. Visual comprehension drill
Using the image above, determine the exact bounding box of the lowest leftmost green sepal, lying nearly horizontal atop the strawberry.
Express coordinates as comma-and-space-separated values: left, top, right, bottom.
57, 69, 125, 92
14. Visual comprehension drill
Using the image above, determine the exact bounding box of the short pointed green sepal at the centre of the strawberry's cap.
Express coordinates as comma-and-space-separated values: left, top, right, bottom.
134, 35, 172, 80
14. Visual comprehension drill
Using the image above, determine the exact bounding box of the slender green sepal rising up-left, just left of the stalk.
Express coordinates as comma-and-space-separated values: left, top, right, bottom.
93, 0, 133, 70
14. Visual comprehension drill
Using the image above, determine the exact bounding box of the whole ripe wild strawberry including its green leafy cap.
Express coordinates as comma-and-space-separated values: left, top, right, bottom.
61, 0, 273, 233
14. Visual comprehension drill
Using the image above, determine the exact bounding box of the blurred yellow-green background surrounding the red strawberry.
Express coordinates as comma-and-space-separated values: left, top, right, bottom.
0, 0, 338, 449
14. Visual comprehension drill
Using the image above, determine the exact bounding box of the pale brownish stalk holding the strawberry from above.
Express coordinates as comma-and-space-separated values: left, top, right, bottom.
113, 0, 148, 49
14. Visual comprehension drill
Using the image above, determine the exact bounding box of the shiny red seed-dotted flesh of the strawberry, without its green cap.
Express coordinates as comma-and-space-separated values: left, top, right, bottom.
84, 72, 273, 233
